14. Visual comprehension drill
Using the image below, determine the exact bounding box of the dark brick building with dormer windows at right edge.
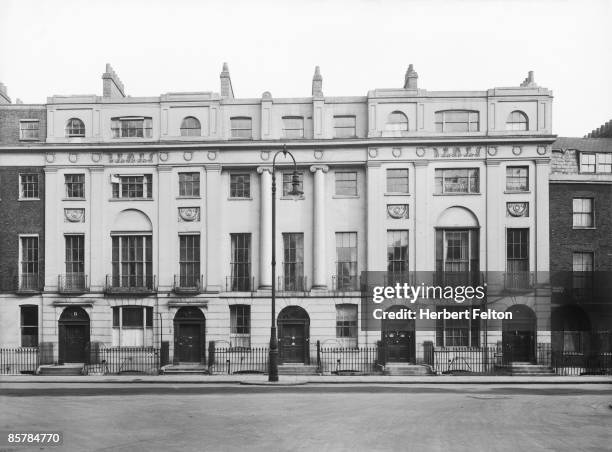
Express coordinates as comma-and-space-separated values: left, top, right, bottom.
550, 138, 612, 354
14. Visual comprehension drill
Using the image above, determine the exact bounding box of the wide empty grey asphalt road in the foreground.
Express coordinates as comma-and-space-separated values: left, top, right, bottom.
0, 384, 612, 452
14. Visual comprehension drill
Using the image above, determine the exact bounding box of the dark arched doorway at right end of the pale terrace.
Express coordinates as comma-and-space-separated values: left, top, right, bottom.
502, 304, 536, 362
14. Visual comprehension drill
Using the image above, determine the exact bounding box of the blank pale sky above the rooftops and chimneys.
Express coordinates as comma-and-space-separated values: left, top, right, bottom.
0, 0, 612, 136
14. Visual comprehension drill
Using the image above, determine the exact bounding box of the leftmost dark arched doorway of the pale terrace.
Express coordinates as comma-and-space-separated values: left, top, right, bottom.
58, 306, 89, 364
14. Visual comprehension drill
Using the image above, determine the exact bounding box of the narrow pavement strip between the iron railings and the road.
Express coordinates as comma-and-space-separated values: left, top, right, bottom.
0, 374, 612, 388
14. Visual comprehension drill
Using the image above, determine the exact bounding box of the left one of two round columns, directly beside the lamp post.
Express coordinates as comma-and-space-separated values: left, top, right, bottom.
257, 166, 272, 290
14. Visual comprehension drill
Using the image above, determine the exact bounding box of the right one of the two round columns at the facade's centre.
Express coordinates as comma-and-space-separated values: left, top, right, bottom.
310, 165, 329, 290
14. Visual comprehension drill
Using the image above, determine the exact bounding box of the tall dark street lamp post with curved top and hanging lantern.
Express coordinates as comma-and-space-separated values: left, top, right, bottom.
268, 145, 302, 381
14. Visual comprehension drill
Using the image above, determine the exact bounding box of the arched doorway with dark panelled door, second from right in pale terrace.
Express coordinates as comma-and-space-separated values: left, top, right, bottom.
381, 306, 416, 363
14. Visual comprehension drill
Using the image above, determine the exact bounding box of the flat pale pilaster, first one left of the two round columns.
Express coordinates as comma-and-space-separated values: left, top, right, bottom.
205, 164, 224, 293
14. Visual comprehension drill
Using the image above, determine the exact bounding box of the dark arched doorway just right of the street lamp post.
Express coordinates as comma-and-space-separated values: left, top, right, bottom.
277, 306, 310, 364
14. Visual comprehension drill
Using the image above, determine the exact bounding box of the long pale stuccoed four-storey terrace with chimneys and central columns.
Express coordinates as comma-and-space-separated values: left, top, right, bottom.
0, 65, 554, 374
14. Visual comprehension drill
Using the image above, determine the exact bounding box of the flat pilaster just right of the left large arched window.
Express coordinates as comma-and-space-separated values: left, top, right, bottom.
155, 166, 177, 291
